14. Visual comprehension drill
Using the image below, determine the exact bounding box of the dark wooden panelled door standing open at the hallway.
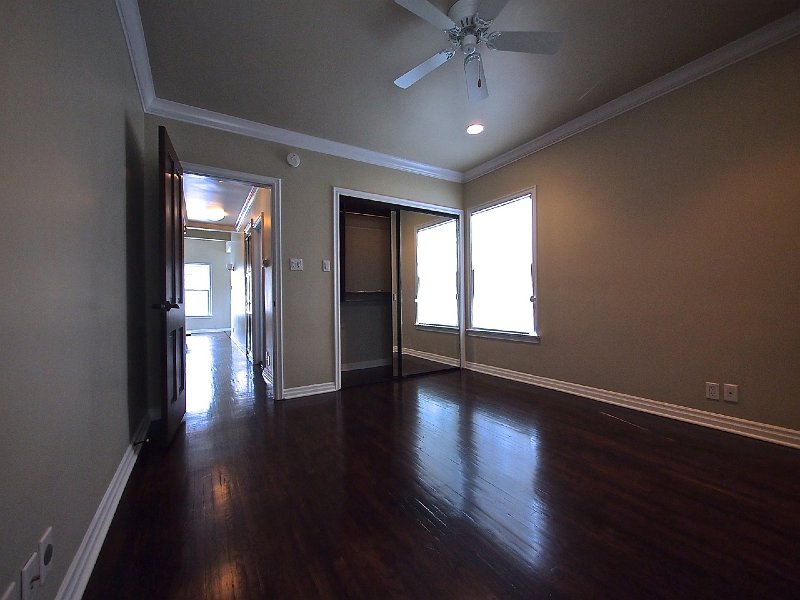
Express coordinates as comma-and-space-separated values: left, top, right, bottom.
158, 127, 186, 443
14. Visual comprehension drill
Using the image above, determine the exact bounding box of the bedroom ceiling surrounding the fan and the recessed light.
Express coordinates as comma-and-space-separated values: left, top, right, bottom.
138, 0, 800, 172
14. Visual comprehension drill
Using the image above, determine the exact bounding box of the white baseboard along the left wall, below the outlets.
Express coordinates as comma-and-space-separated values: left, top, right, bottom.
56, 416, 150, 600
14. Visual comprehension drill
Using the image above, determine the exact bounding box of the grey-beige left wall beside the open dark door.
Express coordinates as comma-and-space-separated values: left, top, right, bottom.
0, 1, 145, 600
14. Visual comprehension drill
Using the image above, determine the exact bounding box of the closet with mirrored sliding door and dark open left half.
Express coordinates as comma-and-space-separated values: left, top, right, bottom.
334, 189, 464, 389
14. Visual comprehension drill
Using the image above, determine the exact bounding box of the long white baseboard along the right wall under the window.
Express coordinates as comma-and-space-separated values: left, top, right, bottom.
467, 362, 800, 448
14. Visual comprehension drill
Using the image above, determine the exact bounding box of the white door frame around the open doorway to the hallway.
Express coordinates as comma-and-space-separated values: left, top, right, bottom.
182, 162, 284, 400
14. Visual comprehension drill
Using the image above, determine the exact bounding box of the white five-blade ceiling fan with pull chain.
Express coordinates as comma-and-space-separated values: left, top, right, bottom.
394, 0, 564, 102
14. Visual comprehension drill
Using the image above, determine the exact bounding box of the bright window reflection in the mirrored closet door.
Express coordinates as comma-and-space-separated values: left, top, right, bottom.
416, 220, 458, 327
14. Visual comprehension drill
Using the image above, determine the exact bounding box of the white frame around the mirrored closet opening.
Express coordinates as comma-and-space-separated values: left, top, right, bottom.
333, 187, 467, 390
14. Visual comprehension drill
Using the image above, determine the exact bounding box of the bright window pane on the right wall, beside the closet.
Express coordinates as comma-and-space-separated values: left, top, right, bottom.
469, 191, 536, 336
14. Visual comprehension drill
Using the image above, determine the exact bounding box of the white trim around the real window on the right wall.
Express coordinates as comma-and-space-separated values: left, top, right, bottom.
464, 186, 541, 344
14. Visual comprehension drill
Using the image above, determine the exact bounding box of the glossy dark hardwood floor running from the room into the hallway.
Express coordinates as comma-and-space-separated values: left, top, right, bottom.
84, 335, 800, 600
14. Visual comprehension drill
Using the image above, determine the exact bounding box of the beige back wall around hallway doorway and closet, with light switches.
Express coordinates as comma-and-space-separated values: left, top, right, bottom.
145, 116, 461, 398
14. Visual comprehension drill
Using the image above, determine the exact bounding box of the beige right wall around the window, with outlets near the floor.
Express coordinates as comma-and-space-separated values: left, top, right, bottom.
465, 38, 800, 429
